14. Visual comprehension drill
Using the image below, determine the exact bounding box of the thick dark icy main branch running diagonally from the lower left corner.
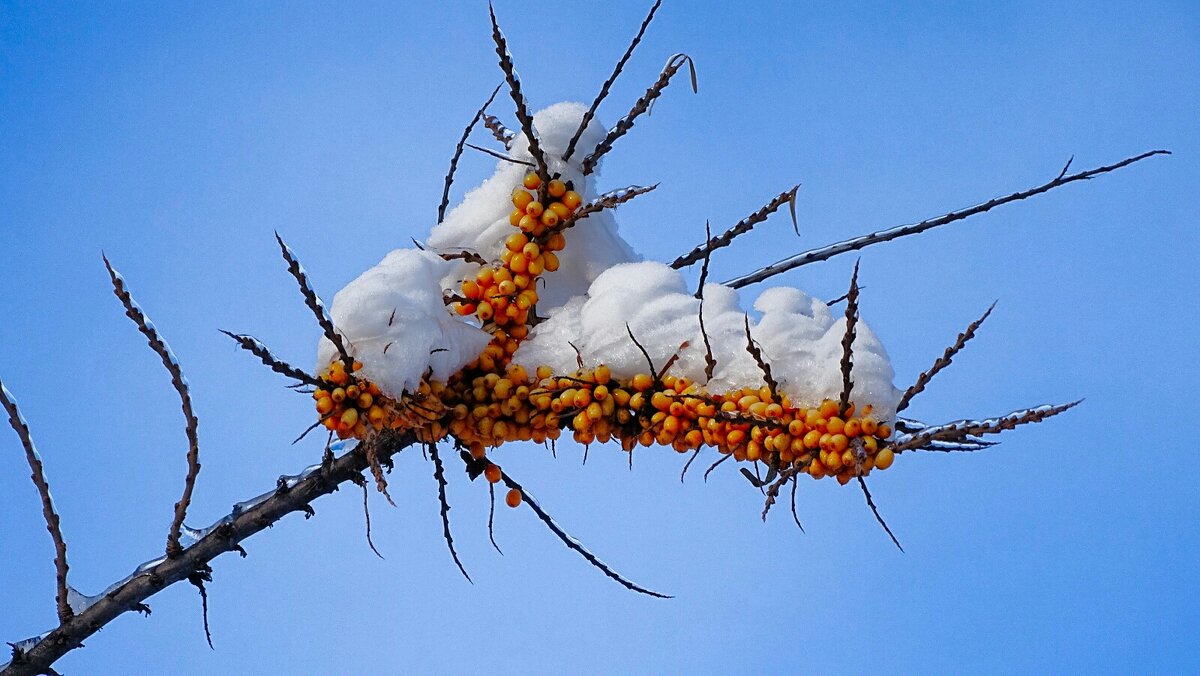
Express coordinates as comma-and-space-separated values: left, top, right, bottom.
0, 430, 415, 676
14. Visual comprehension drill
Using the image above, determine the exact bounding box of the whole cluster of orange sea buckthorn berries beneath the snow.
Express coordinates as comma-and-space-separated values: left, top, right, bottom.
314, 173, 895, 497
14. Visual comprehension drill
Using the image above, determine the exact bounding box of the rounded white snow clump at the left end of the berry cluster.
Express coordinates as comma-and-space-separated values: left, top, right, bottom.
317, 249, 491, 397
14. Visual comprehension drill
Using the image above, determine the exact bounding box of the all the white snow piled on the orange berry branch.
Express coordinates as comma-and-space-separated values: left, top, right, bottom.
319, 103, 900, 419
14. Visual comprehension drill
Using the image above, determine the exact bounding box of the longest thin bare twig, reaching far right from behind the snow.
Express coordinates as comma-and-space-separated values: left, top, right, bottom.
725, 150, 1171, 288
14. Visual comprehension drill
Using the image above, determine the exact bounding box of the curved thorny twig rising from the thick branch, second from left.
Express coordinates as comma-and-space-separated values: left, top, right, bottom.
101, 255, 200, 556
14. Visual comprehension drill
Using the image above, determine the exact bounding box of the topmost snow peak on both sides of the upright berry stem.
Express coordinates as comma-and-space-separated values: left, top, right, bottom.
428, 103, 641, 313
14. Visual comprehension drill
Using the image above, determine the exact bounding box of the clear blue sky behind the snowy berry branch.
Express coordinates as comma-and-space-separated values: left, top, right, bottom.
0, 0, 1200, 674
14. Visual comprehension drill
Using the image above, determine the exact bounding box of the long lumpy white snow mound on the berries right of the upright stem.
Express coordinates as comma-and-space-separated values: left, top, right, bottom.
514, 262, 900, 419
